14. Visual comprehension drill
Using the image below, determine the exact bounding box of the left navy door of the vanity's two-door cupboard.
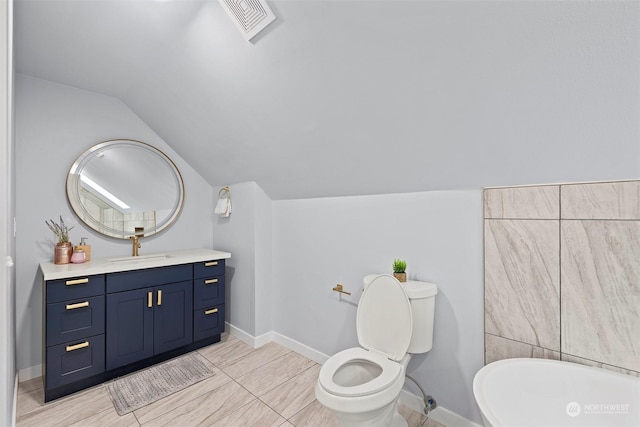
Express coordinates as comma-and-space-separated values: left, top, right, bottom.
106, 288, 154, 370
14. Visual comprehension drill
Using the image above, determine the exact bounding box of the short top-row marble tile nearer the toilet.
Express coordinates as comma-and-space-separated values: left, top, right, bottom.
484, 185, 560, 219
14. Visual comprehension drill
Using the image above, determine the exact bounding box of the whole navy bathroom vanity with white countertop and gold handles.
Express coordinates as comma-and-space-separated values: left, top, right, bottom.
40, 249, 231, 402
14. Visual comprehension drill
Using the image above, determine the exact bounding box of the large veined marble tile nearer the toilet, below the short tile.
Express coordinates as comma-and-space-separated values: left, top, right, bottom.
485, 220, 560, 351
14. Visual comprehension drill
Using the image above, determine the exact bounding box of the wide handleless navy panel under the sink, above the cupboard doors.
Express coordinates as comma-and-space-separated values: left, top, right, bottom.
107, 264, 193, 293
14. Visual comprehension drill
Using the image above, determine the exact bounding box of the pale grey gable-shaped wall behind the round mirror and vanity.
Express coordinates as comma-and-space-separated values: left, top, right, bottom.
15, 74, 214, 375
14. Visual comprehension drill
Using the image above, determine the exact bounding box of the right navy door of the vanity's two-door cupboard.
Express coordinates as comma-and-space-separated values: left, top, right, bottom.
154, 280, 193, 354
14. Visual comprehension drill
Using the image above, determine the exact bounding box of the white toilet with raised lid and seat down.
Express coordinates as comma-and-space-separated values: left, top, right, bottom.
316, 274, 438, 427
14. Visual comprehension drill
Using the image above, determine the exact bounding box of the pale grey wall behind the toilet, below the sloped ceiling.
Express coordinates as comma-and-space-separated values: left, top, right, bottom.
273, 190, 483, 421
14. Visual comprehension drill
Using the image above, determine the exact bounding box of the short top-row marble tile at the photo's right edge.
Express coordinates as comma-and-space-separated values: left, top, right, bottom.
561, 181, 640, 220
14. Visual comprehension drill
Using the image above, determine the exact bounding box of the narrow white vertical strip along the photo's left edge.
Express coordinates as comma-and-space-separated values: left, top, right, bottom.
0, 0, 16, 426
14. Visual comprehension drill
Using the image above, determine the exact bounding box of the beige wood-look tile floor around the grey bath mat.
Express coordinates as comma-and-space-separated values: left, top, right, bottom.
16, 334, 444, 427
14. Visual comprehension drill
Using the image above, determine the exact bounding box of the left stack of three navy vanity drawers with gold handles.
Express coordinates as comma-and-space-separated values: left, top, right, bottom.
43, 274, 105, 401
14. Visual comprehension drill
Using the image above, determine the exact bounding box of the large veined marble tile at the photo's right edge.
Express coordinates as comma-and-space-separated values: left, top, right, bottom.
561, 220, 640, 371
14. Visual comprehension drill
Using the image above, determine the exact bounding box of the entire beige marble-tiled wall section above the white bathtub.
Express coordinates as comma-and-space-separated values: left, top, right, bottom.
484, 181, 640, 376
